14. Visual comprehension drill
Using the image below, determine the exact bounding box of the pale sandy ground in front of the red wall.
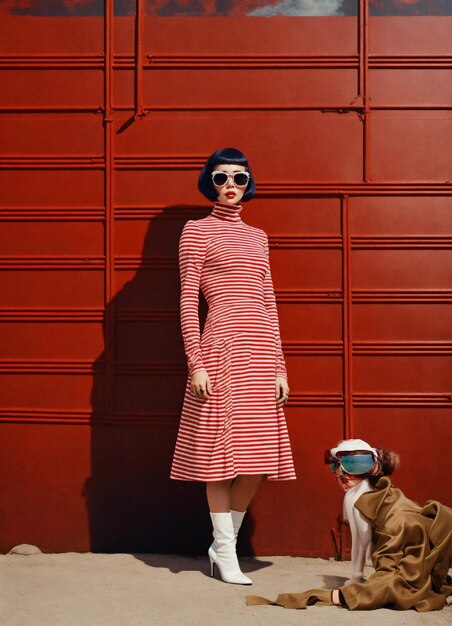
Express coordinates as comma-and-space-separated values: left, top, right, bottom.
0, 553, 452, 626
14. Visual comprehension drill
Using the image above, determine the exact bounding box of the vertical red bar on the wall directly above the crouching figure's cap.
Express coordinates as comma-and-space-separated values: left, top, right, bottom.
341, 195, 353, 439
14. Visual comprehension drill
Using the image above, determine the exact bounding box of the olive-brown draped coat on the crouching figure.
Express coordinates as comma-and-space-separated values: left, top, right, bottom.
247, 477, 452, 611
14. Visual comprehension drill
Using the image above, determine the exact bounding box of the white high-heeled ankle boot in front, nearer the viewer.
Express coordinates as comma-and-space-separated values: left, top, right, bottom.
209, 512, 252, 585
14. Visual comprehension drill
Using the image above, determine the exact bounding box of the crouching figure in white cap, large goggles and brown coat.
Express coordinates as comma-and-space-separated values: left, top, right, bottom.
247, 439, 452, 611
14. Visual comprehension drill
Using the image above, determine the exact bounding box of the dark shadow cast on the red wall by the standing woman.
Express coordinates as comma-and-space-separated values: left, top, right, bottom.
85, 206, 253, 555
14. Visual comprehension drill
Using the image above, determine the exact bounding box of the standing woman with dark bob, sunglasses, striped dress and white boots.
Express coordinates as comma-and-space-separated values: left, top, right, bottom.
171, 148, 295, 585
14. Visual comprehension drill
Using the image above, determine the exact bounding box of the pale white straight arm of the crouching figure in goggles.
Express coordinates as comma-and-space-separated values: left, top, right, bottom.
344, 480, 372, 582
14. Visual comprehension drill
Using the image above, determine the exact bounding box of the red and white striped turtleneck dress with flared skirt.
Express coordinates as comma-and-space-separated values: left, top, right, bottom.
171, 202, 296, 481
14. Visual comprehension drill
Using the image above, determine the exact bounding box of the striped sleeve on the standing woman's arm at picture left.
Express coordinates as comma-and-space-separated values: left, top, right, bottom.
179, 221, 206, 376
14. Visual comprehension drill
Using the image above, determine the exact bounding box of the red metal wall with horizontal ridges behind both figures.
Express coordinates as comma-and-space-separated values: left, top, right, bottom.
0, 0, 452, 556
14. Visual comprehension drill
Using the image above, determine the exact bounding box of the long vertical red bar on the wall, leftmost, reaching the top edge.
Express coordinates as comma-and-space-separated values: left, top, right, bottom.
104, 0, 114, 419
